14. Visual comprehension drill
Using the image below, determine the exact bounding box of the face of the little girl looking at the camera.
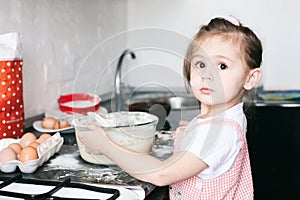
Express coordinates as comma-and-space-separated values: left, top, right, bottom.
190, 36, 251, 109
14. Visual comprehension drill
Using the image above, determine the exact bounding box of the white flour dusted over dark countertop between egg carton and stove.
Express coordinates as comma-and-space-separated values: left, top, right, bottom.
40, 146, 140, 185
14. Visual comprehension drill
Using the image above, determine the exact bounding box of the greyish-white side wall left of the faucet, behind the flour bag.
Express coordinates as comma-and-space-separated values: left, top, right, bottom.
0, 0, 127, 118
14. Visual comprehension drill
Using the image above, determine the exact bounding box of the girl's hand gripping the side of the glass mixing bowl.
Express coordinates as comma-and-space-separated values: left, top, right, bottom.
77, 124, 109, 155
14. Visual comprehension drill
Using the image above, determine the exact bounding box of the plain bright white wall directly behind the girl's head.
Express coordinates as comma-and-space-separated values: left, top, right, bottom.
127, 0, 300, 90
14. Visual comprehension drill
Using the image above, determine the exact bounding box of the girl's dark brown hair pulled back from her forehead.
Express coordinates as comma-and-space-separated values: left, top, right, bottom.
183, 18, 262, 85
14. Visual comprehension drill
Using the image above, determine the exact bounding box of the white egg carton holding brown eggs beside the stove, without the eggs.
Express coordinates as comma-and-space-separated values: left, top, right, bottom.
0, 132, 64, 173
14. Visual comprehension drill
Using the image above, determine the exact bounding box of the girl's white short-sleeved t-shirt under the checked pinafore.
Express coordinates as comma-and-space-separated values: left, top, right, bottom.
180, 103, 247, 179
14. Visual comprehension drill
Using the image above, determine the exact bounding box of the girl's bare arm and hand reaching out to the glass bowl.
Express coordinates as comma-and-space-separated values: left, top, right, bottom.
77, 125, 208, 186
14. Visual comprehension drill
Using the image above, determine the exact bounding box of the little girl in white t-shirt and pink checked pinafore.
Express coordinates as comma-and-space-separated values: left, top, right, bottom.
79, 17, 262, 200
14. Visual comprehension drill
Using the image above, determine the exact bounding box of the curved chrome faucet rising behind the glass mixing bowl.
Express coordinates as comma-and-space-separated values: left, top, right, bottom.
115, 49, 136, 112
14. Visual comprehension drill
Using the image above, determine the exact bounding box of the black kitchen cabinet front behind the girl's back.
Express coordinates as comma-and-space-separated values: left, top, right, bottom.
247, 102, 300, 200
